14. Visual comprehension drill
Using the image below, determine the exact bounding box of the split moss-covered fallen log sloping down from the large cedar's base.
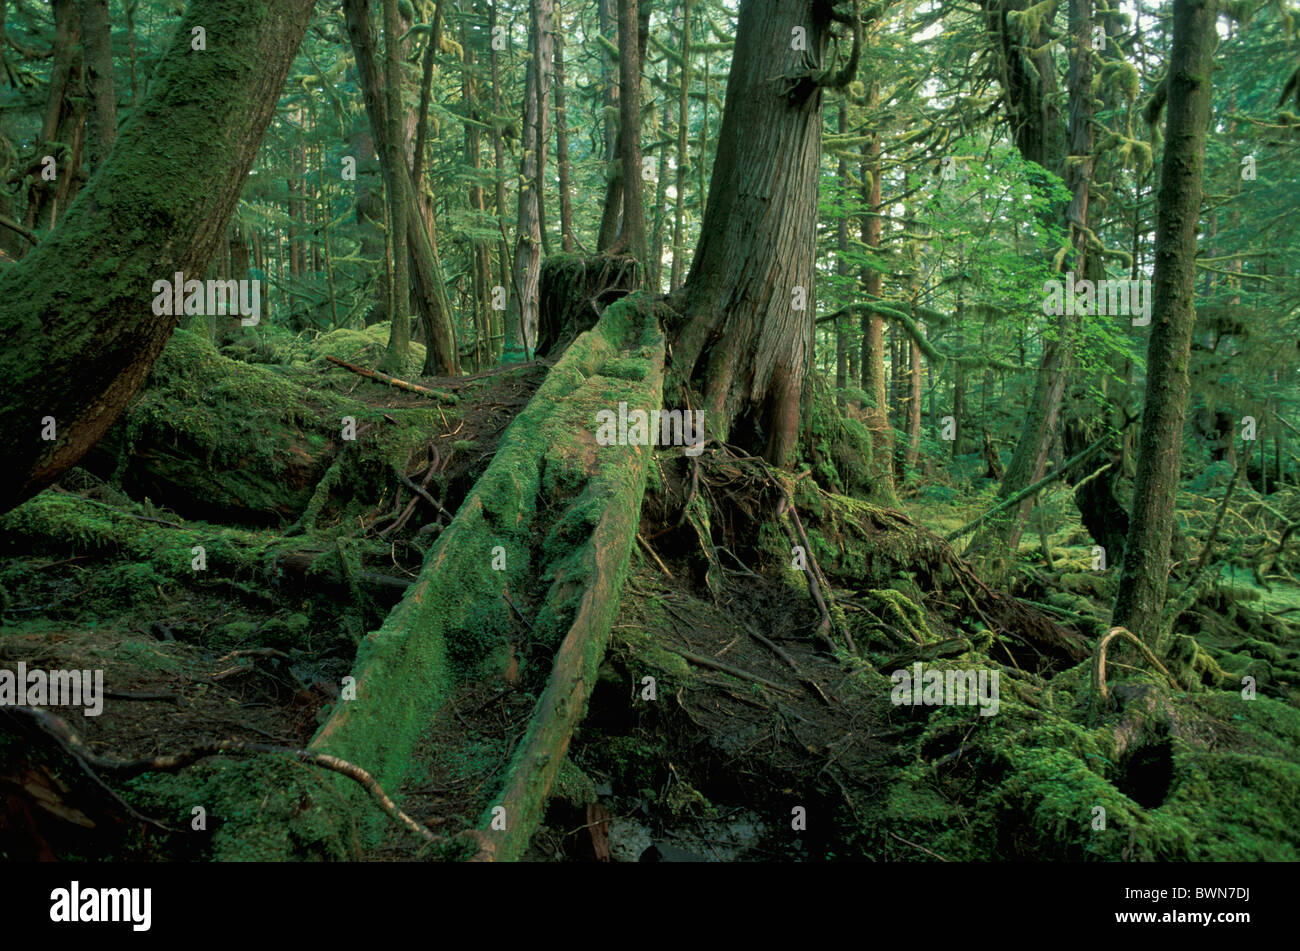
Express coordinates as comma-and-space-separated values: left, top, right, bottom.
215, 298, 664, 859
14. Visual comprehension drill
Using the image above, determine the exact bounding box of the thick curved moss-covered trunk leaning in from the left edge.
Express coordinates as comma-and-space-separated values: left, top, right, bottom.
0, 0, 315, 509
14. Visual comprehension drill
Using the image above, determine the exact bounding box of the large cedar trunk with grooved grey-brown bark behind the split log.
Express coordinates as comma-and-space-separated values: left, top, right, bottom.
672, 0, 859, 464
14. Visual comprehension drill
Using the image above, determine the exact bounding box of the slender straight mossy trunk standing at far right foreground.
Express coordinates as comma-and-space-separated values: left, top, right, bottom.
1114, 0, 1216, 644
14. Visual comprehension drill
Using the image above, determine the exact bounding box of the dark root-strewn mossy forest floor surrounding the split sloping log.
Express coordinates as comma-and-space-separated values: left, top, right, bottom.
0, 314, 1300, 861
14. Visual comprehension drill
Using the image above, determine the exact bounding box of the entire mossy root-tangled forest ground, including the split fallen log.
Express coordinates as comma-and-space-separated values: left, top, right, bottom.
0, 274, 1300, 860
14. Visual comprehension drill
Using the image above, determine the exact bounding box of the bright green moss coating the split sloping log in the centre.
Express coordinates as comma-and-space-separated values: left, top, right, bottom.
215, 291, 663, 851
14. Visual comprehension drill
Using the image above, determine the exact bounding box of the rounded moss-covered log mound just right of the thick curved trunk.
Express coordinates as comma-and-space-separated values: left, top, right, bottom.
103, 330, 452, 525
